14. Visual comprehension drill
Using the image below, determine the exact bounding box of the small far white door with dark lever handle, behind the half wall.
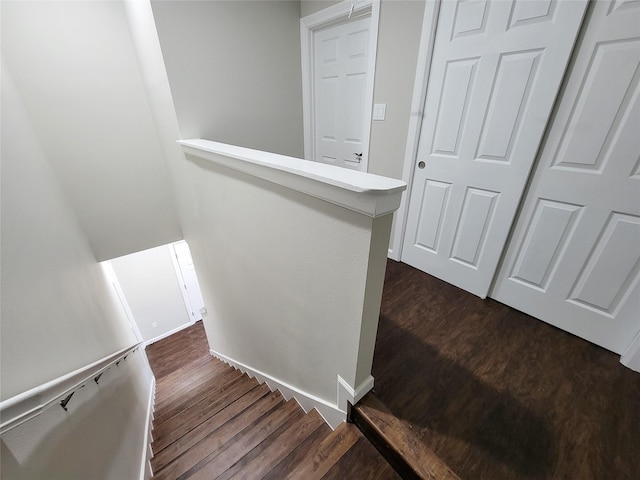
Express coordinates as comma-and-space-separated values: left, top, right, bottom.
314, 17, 371, 170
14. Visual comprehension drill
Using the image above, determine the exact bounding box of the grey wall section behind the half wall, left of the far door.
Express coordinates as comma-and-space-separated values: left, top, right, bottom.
152, 1, 303, 158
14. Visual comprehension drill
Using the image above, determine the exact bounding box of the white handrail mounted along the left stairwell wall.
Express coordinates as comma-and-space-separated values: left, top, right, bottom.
0, 343, 142, 434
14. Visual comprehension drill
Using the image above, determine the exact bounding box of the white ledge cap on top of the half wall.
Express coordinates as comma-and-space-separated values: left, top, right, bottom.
178, 139, 407, 217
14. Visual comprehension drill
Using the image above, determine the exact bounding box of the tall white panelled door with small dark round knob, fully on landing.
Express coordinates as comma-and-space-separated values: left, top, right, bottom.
402, 0, 586, 297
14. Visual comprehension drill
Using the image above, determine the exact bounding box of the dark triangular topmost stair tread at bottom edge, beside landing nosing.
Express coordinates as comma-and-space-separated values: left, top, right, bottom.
322, 437, 402, 480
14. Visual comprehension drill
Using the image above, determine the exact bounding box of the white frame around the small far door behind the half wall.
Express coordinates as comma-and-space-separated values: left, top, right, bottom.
300, 0, 380, 172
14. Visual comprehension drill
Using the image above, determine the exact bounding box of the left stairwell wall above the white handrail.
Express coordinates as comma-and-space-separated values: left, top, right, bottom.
0, 57, 135, 400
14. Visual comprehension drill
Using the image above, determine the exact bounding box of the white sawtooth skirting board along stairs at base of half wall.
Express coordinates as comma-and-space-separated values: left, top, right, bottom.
209, 350, 347, 430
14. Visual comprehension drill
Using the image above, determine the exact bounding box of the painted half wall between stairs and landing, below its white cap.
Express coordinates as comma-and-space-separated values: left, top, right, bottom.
178, 151, 390, 412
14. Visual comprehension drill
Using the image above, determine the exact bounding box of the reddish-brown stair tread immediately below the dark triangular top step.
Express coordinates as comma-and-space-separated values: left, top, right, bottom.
285, 423, 360, 479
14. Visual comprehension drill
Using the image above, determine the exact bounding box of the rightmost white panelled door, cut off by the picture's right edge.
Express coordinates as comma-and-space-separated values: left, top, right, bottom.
491, 1, 640, 353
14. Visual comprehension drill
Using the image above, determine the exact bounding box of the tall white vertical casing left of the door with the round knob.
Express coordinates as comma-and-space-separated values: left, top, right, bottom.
389, 0, 440, 261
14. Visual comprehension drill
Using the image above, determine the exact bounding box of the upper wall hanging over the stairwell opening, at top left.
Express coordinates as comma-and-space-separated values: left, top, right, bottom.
1, 1, 182, 260
